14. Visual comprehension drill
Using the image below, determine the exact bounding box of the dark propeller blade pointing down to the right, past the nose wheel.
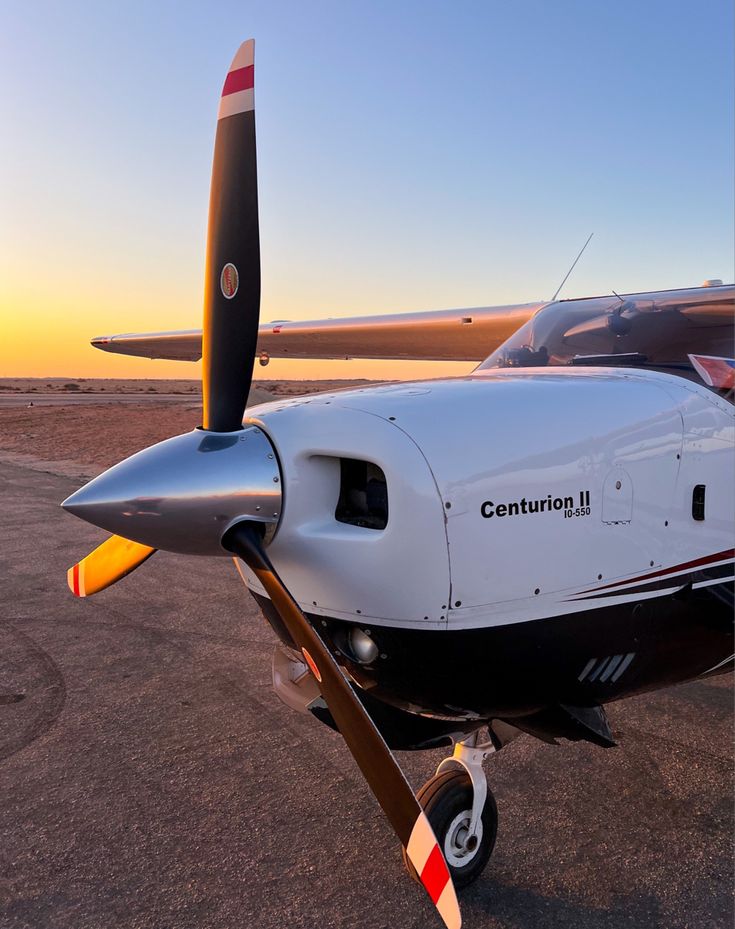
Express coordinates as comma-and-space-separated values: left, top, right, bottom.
222, 522, 462, 929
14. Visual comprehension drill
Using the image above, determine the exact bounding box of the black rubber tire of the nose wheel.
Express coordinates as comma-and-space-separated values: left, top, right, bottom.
403, 769, 498, 889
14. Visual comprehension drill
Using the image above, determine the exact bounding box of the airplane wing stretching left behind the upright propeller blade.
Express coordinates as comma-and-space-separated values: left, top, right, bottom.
92, 302, 544, 361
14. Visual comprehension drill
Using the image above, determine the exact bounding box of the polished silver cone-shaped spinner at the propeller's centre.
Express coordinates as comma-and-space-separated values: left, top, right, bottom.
62, 426, 282, 555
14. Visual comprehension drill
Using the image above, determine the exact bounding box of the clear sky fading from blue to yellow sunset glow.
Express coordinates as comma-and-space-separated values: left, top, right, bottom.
0, 0, 735, 378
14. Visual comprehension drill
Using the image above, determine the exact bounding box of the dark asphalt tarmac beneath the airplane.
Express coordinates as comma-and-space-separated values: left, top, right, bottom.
0, 458, 734, 929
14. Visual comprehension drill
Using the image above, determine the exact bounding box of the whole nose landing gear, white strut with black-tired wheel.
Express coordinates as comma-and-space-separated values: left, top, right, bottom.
403, 732, 498, 888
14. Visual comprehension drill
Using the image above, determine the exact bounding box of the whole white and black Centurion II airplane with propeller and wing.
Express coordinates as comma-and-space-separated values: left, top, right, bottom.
63, 40, 735, 927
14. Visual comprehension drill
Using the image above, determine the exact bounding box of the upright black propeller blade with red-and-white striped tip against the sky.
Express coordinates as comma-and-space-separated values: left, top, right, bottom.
202, 39, 260, 432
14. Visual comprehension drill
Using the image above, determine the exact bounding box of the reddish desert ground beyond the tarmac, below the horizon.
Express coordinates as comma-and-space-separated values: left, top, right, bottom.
0, 378, 370, 480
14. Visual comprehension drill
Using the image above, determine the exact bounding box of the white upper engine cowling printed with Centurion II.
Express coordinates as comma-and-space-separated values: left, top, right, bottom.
246, 368, 735, 630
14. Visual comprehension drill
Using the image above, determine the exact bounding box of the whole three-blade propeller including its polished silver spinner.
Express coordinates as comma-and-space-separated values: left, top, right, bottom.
62, 40, 461, 929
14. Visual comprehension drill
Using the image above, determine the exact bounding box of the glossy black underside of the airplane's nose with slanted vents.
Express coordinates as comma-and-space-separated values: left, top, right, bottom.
250, 584, 733, 719
